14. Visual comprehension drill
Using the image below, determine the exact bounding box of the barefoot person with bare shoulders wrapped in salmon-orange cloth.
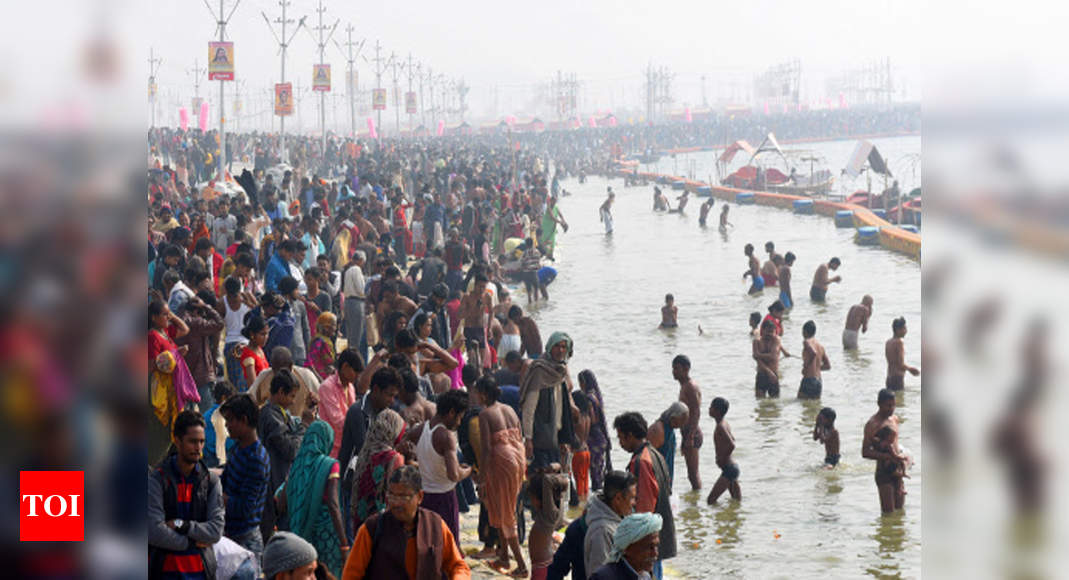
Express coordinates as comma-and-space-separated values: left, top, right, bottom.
475, 377, 527, 578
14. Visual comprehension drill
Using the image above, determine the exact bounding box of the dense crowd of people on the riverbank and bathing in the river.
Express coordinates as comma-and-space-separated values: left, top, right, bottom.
148, 105, 916, 579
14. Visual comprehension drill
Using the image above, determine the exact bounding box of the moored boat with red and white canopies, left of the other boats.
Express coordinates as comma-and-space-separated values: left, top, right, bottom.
716, 132, 835, 197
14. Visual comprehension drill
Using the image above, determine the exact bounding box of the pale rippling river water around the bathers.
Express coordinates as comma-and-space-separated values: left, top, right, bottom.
523, 139, 923, 578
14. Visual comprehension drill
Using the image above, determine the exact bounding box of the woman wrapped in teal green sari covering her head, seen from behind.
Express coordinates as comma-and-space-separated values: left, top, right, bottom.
278, 421, 348, 578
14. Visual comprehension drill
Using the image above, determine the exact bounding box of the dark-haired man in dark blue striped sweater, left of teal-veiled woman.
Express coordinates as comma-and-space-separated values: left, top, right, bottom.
219, 394, 270, 559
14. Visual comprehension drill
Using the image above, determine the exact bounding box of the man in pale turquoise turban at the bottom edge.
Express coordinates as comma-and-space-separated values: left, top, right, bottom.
590, 514, 661, 580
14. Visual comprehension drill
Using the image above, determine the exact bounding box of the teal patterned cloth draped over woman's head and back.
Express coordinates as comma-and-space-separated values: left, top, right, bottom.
285, 421, 338, 539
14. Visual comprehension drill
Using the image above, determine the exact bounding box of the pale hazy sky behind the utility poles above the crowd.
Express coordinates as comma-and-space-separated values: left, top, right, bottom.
145, 0, 923, 125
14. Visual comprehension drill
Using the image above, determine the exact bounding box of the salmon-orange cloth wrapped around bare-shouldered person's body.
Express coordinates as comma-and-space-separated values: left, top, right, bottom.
481, 428, 527, 538
